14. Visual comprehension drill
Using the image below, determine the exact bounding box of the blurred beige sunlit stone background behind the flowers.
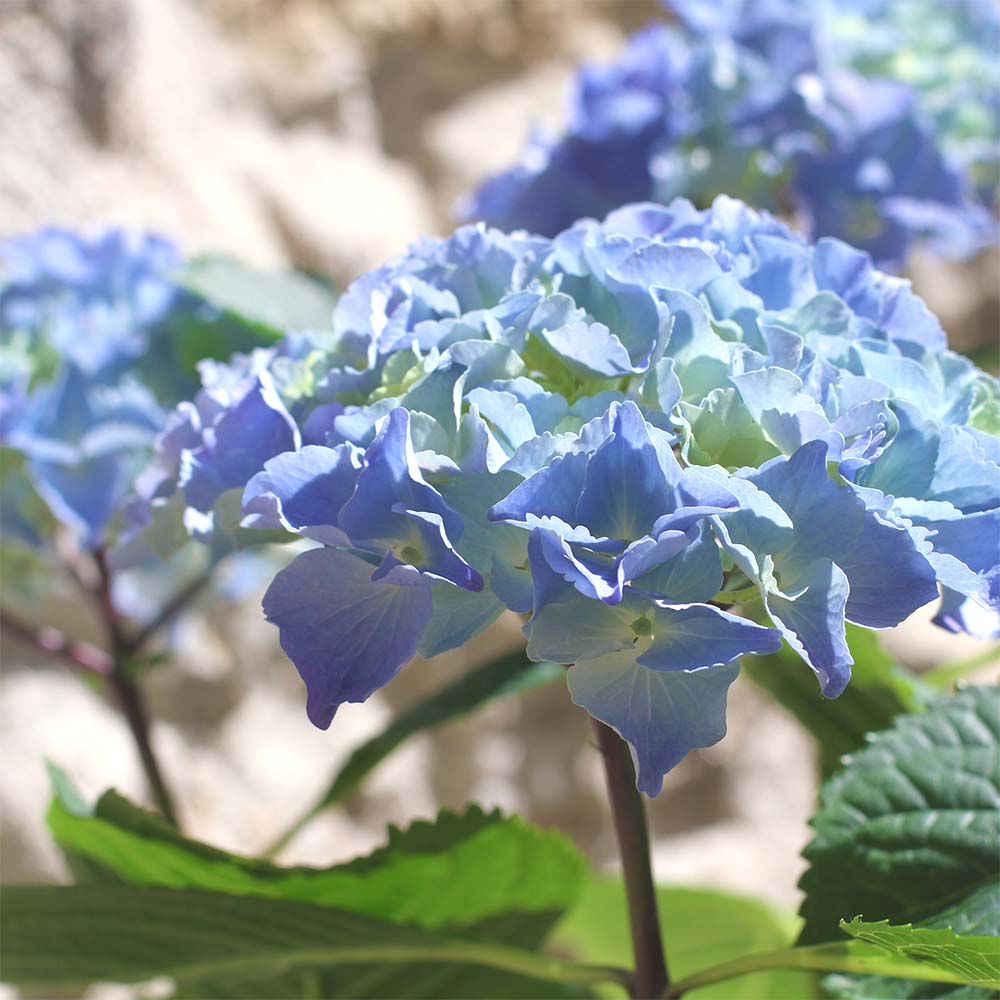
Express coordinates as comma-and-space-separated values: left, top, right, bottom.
0, 0, 1000, 920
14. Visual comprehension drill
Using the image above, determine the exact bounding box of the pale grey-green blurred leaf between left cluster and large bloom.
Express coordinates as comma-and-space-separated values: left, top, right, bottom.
176, 255, 336, 336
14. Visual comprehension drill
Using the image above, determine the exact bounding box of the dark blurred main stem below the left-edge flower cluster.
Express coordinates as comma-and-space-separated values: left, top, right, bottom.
94, 549, 177, 826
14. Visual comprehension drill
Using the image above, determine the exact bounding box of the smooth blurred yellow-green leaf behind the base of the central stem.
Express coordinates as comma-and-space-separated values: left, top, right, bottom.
552, 875, 818, 1000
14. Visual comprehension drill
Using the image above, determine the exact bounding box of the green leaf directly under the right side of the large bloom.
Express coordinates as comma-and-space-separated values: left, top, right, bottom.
740, 625, 923, 776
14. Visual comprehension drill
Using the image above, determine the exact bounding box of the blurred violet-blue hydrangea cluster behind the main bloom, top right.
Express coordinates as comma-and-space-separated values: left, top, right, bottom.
460, 0, 1000, 267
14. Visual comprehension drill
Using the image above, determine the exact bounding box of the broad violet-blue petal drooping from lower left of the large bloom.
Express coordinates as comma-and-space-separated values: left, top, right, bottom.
264, 548, 431, 729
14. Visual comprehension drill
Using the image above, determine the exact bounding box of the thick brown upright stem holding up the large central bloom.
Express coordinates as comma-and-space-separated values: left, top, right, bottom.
593, 719, 670, 1000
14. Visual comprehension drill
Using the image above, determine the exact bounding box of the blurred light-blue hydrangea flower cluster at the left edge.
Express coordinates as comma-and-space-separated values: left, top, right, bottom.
0, 228, 182, 548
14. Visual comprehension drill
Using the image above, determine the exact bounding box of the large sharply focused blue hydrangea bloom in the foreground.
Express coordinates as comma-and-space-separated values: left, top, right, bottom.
150, 198, 1000, 794
